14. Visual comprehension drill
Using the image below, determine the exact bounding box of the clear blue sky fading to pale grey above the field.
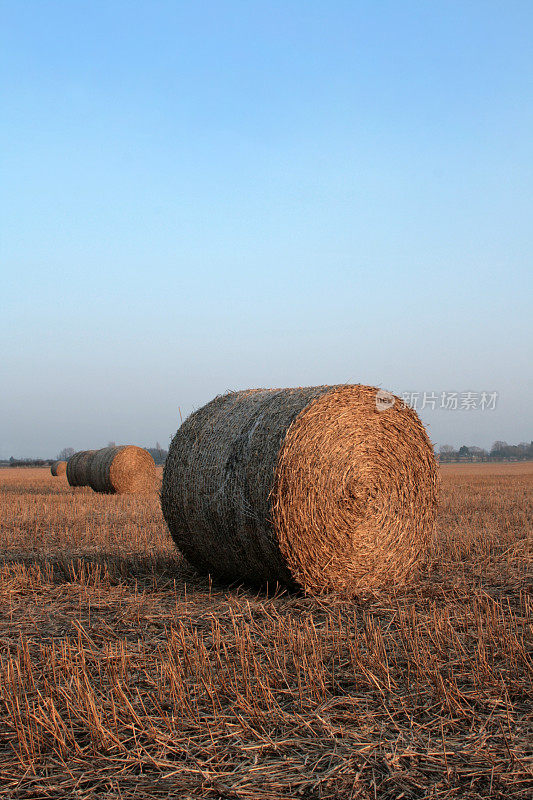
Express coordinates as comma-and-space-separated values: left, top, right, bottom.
0, 0, 533, 458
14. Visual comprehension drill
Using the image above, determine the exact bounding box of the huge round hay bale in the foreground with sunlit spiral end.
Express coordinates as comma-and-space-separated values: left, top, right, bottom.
161, 385, 437, 594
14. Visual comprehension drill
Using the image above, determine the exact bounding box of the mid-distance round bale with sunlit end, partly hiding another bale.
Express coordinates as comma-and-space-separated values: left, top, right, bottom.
89, 445, 156, 494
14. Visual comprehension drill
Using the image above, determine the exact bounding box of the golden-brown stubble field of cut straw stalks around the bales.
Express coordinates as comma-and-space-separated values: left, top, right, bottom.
0, 464, 533, 800
